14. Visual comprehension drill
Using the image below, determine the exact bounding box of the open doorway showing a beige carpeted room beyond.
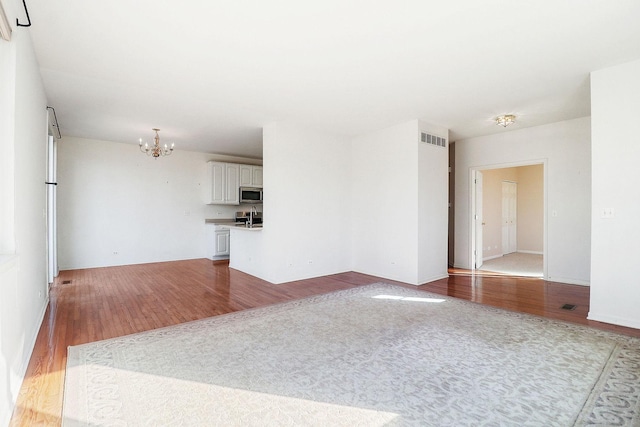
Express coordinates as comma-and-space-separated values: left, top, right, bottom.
471, 161, 546, 277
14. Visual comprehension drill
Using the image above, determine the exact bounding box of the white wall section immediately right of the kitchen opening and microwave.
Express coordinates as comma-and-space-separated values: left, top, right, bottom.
256, 123, 351, 283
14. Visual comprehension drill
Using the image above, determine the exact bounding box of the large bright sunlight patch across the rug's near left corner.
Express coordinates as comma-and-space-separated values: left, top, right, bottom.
64, 364, 399, 427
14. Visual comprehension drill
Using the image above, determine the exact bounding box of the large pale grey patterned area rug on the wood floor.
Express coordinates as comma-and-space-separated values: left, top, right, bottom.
63, 284, 640, 426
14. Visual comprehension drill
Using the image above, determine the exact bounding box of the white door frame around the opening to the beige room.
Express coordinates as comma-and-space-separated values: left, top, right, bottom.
468, 158, 549, 280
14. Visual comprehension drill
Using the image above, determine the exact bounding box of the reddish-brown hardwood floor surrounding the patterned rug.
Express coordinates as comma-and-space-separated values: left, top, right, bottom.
11, 259, 640, 426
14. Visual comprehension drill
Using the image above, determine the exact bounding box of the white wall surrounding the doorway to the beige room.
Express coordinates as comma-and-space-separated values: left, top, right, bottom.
454, 117, 591, 285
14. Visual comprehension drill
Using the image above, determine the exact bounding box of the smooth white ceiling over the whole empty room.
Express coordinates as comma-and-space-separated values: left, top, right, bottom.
22, 0, 640, 157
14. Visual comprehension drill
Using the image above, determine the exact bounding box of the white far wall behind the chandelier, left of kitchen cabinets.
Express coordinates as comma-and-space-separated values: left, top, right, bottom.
58, 137, 260, 270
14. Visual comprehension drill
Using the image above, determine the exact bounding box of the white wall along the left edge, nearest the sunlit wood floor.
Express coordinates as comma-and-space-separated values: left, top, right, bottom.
0, 11, 47, 425
